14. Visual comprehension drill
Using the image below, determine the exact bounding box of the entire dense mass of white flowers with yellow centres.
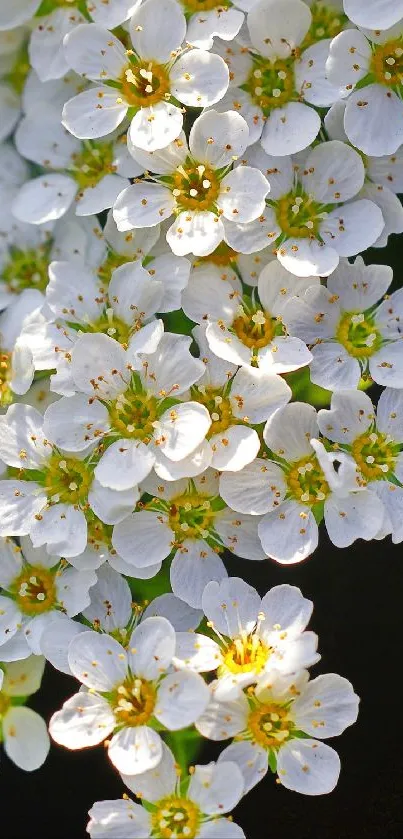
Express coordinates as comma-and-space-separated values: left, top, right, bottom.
0, 0, 403, 839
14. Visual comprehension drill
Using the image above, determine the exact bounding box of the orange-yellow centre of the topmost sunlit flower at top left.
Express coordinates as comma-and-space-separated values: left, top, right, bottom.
119, 59, 170, 108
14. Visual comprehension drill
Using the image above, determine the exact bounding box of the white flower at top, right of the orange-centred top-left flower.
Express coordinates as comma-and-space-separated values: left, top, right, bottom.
210, 0, 345, 155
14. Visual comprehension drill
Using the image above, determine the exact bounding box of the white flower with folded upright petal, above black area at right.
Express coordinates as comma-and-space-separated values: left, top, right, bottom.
220, 402, 383, 563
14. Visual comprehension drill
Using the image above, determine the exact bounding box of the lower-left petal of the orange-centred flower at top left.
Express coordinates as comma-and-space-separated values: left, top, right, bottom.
62, 88, 127, 140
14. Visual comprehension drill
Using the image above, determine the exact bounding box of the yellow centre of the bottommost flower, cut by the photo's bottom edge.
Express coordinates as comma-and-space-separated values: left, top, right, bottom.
151, 795, 201, 839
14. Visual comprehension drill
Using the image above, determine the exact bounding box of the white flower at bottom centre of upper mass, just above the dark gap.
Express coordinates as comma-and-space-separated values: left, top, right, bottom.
112, 470, 264, 609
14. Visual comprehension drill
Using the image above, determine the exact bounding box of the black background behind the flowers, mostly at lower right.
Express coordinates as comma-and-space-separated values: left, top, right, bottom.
0, 237, 403, 839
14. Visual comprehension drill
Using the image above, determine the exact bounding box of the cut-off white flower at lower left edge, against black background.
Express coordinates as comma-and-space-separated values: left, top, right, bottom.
0, 656, 50, 772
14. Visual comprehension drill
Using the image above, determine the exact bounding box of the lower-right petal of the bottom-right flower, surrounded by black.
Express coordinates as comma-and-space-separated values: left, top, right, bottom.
277, 740, 340, 795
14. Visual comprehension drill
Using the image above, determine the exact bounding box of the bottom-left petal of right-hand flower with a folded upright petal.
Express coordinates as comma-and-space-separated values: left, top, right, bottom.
258, 501, 318, 564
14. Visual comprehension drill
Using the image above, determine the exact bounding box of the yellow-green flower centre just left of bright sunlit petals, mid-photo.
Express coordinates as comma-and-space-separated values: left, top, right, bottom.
109, 390, 158, 444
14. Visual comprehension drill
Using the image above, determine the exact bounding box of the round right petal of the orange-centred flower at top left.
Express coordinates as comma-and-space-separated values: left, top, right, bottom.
170, 49, 229, 108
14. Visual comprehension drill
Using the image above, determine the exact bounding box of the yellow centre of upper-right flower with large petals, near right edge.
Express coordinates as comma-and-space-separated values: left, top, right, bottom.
274, 191, 324, 239
